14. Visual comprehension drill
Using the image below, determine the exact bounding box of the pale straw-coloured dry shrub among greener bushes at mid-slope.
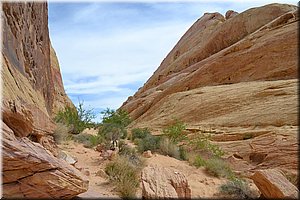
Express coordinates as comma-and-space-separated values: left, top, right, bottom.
158, 138, 180, 159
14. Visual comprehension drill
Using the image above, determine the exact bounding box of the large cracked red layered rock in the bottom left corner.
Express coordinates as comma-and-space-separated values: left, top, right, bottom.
2, 123, 88, 198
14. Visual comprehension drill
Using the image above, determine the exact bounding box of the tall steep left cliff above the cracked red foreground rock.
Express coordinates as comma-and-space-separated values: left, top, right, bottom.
2, 3, 72, 141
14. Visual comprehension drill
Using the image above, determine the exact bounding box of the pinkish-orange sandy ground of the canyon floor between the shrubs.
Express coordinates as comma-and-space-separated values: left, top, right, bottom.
59, 129, 257, 199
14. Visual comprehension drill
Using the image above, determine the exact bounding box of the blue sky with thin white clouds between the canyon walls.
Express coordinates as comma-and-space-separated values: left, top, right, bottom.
48, 0, 297, 121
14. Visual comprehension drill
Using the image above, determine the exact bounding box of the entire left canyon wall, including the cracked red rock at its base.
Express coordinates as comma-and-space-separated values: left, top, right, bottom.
1, 2, 87, 198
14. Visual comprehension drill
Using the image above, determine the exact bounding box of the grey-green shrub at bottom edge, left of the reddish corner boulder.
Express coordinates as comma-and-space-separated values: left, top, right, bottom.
220, 178, 257, 199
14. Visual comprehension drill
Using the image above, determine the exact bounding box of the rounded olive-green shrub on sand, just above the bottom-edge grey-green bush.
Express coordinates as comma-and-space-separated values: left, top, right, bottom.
204, 157, 235, 179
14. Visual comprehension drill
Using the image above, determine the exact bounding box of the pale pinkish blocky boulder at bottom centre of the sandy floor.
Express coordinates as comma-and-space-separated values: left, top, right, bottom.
142, 167, 191, 199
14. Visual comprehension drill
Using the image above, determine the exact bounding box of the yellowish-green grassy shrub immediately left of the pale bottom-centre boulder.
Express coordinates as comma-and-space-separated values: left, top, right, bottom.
105, 156, 141, 198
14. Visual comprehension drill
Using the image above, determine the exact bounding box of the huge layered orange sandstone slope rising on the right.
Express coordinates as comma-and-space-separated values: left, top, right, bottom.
121, 4, 299, 178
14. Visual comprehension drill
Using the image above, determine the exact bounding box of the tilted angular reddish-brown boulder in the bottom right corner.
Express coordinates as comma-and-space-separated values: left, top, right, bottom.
251, 169, 299, 199
